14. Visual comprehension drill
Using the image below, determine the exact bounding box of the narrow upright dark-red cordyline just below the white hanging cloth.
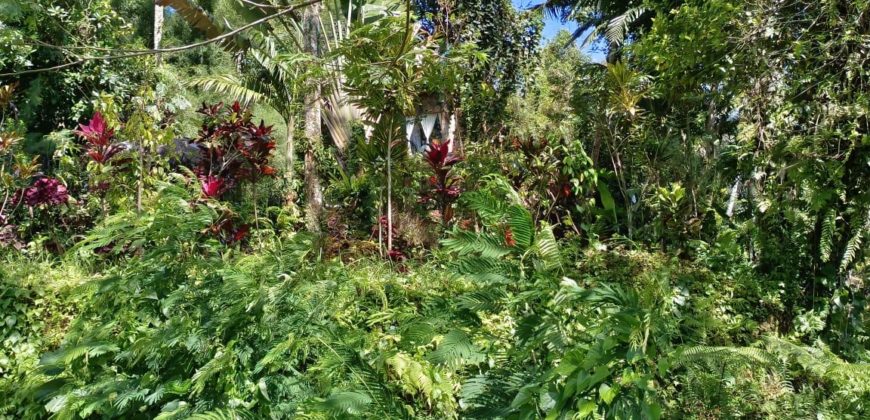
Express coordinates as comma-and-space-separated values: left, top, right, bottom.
421, 140, 462, 223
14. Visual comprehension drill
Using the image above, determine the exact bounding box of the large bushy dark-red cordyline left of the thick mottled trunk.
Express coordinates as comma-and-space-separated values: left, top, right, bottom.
194, 102, 276, 198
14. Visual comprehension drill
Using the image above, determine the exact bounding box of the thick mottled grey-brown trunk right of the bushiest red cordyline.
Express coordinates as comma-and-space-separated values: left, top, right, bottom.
302, 3, 323, 232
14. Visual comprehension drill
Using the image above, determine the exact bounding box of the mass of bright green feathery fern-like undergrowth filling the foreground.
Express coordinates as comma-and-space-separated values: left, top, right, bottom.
0, 177, 870, 419
